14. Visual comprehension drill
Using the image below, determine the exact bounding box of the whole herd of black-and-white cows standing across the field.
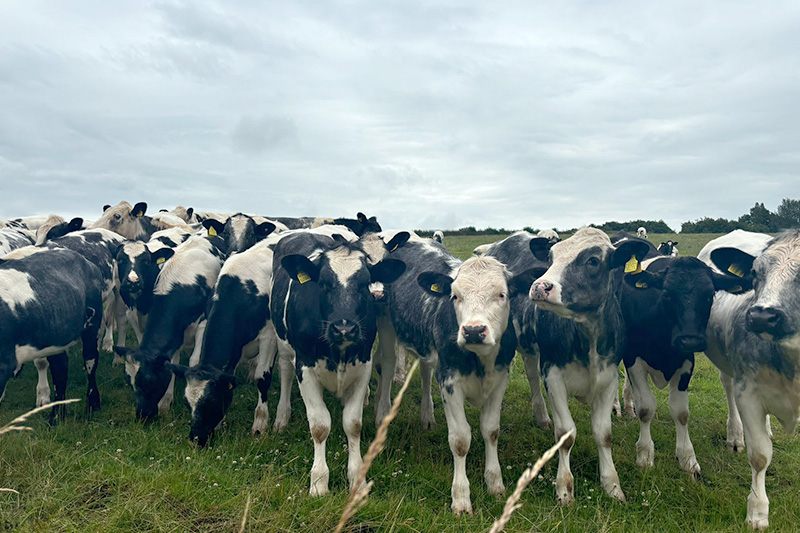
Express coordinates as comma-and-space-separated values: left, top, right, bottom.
0, 202, 800, 529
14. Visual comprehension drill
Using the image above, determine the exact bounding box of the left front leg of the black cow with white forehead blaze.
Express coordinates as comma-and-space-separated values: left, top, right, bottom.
298, 369, 330, 496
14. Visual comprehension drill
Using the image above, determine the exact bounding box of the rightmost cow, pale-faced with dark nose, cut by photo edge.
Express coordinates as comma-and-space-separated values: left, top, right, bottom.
706, 229, 800, 529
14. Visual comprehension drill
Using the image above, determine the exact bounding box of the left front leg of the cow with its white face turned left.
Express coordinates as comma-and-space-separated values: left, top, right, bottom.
545, 367, 575, 505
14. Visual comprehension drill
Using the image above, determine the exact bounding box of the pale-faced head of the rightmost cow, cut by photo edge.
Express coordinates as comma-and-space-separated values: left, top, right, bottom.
711, 229, 800, 344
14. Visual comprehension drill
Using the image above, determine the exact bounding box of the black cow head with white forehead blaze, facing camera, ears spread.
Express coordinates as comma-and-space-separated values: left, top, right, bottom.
281, 240, 406, 352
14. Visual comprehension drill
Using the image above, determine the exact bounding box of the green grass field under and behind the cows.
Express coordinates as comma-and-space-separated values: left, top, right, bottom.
0, 235, 800, 533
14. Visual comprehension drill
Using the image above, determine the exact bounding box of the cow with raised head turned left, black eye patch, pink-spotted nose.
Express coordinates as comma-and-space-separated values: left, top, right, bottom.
530, 228, 648, 504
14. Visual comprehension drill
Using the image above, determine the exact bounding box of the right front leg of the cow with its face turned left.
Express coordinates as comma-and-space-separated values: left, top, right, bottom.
592, 366, 625, 503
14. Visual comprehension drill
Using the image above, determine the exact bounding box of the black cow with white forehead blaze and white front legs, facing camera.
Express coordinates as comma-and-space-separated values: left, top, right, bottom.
270, 233, 405, 496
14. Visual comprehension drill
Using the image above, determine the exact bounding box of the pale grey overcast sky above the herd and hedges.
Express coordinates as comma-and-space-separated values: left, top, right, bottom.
0, 0, 800, 229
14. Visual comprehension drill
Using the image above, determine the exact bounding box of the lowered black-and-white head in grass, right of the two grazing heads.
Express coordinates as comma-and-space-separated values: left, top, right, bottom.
168, 364, 236, 446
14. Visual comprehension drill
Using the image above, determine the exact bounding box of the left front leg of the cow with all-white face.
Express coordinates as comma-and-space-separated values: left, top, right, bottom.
440, 383, 472, 514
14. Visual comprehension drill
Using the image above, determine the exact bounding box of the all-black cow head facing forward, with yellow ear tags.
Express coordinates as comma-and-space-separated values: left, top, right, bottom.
624, 257, 750, 353
